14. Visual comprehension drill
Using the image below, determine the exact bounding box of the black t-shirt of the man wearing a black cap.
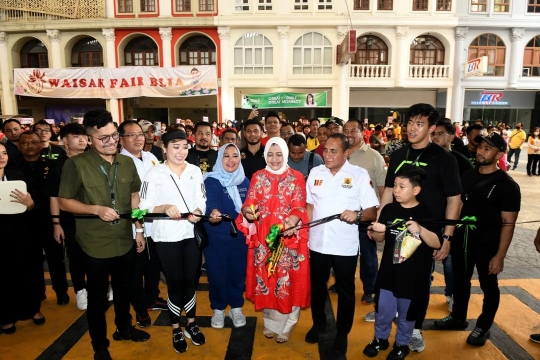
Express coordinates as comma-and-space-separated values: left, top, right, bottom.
458, 169, 521, 248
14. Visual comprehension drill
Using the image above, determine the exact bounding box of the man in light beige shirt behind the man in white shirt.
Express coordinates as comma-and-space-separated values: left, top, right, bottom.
343, 120, 386, 304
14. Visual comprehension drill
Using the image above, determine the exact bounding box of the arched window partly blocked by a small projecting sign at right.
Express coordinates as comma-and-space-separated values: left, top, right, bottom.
467, 34, 506, 76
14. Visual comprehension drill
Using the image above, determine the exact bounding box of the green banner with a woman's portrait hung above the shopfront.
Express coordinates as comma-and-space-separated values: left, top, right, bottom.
242, 91, 326, 109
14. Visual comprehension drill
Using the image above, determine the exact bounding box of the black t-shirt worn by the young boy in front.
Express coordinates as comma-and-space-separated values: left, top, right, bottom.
376, 202, 441, 300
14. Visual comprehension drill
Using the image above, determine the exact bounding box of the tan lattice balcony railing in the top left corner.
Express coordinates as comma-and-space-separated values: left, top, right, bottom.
0, 0, 106, 22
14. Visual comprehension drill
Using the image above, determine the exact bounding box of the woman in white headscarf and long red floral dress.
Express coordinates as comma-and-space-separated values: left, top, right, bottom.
236, 137, 310, 343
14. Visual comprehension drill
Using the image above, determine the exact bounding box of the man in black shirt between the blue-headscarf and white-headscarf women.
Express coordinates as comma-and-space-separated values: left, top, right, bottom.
240, 120, 266, 181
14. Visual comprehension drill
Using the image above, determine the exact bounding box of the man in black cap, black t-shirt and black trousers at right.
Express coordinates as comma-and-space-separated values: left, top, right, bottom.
435, 132, 521, 346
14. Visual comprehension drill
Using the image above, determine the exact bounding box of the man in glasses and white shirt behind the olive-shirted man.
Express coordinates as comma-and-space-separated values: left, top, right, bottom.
118, 120, 168, 328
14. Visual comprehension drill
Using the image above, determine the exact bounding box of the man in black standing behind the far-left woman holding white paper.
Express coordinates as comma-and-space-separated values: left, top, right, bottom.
10, 131, 69, 305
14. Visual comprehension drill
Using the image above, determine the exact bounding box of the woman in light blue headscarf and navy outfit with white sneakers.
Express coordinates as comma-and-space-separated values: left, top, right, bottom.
203, 144, 249, 329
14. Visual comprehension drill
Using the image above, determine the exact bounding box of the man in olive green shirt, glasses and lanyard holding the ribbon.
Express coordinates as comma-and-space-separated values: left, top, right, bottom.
58, 110, 150, 360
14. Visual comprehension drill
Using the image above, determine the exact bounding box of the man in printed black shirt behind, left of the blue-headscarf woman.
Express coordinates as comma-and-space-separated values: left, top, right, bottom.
186, 121, 217, 174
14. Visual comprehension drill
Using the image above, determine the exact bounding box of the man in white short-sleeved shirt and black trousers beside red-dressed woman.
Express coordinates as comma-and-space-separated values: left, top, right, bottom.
305, 134, 379, 356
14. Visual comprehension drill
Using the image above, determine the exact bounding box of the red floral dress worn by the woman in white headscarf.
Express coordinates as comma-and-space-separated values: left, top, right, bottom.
236, 168, 310, 314
